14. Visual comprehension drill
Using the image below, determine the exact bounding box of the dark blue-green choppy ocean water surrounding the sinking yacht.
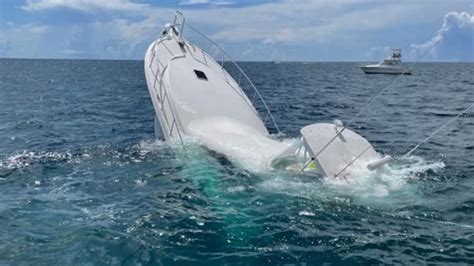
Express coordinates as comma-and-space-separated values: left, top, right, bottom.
0, 59, 474, 265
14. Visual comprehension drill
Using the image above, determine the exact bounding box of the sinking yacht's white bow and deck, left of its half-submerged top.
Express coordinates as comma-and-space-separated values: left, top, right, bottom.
145, 26, 287, 171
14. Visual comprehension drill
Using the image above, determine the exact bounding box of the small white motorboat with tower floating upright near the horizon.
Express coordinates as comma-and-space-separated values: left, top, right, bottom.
359, 49, 411, 75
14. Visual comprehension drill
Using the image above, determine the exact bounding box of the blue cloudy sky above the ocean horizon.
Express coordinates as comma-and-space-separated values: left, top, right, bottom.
0, 0, 474, 62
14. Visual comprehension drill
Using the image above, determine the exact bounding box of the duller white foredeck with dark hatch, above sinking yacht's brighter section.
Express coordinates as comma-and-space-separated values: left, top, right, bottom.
145, 29, 268, 140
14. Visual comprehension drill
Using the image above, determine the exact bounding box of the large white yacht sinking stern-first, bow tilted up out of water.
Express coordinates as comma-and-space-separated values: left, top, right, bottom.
145, 12, 389, 177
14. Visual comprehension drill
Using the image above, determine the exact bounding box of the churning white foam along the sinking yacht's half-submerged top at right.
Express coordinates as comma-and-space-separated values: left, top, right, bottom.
258, 153, 445, 204
